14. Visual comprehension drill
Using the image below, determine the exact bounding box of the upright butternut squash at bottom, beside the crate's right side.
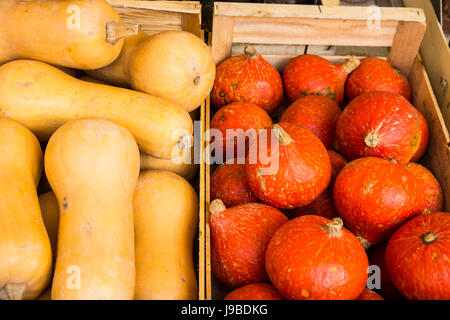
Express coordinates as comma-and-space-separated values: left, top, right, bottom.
134, 170, 198, 300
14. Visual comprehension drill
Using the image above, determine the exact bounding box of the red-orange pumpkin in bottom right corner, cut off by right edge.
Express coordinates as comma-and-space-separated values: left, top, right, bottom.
386, 212, 450, 300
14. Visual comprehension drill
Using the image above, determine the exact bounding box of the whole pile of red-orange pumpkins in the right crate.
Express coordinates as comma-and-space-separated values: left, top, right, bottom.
209, 47, 450, 300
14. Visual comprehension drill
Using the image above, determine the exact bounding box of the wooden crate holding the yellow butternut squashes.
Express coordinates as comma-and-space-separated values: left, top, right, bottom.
107, 0, 206, 299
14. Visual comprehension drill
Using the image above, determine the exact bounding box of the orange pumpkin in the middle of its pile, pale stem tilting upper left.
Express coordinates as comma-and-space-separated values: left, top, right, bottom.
245, 122, 331, 209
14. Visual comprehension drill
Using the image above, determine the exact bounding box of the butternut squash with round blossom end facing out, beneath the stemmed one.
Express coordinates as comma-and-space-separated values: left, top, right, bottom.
87, 30, 216, 112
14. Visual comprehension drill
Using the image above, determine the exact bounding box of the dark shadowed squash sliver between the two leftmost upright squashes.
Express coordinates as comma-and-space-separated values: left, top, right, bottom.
39, 191, 59, 255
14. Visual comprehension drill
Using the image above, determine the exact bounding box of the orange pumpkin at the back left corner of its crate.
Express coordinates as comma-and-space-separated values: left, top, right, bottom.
211, 47, 283, 115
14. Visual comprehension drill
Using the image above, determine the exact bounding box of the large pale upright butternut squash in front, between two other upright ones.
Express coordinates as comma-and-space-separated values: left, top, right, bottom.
45, 119, 139, 300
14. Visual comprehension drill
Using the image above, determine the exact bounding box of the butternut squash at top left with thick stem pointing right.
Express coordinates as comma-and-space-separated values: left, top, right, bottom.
0, 0, 139, 69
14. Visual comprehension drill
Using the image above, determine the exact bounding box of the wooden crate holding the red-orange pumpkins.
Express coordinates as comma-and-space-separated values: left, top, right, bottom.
205, 2, 450, 299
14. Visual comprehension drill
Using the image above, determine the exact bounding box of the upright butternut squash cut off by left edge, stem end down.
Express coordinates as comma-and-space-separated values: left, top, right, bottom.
0, 118, 52, 300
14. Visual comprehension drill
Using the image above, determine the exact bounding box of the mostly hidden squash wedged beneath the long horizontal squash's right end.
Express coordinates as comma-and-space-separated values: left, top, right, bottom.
141, 146, 199, 181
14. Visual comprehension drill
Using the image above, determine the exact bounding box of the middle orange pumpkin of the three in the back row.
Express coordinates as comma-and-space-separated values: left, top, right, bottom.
283, 54, 347, 105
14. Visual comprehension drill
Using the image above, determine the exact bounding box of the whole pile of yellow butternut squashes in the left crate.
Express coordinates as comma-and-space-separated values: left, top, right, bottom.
0, 0, 215, 299
